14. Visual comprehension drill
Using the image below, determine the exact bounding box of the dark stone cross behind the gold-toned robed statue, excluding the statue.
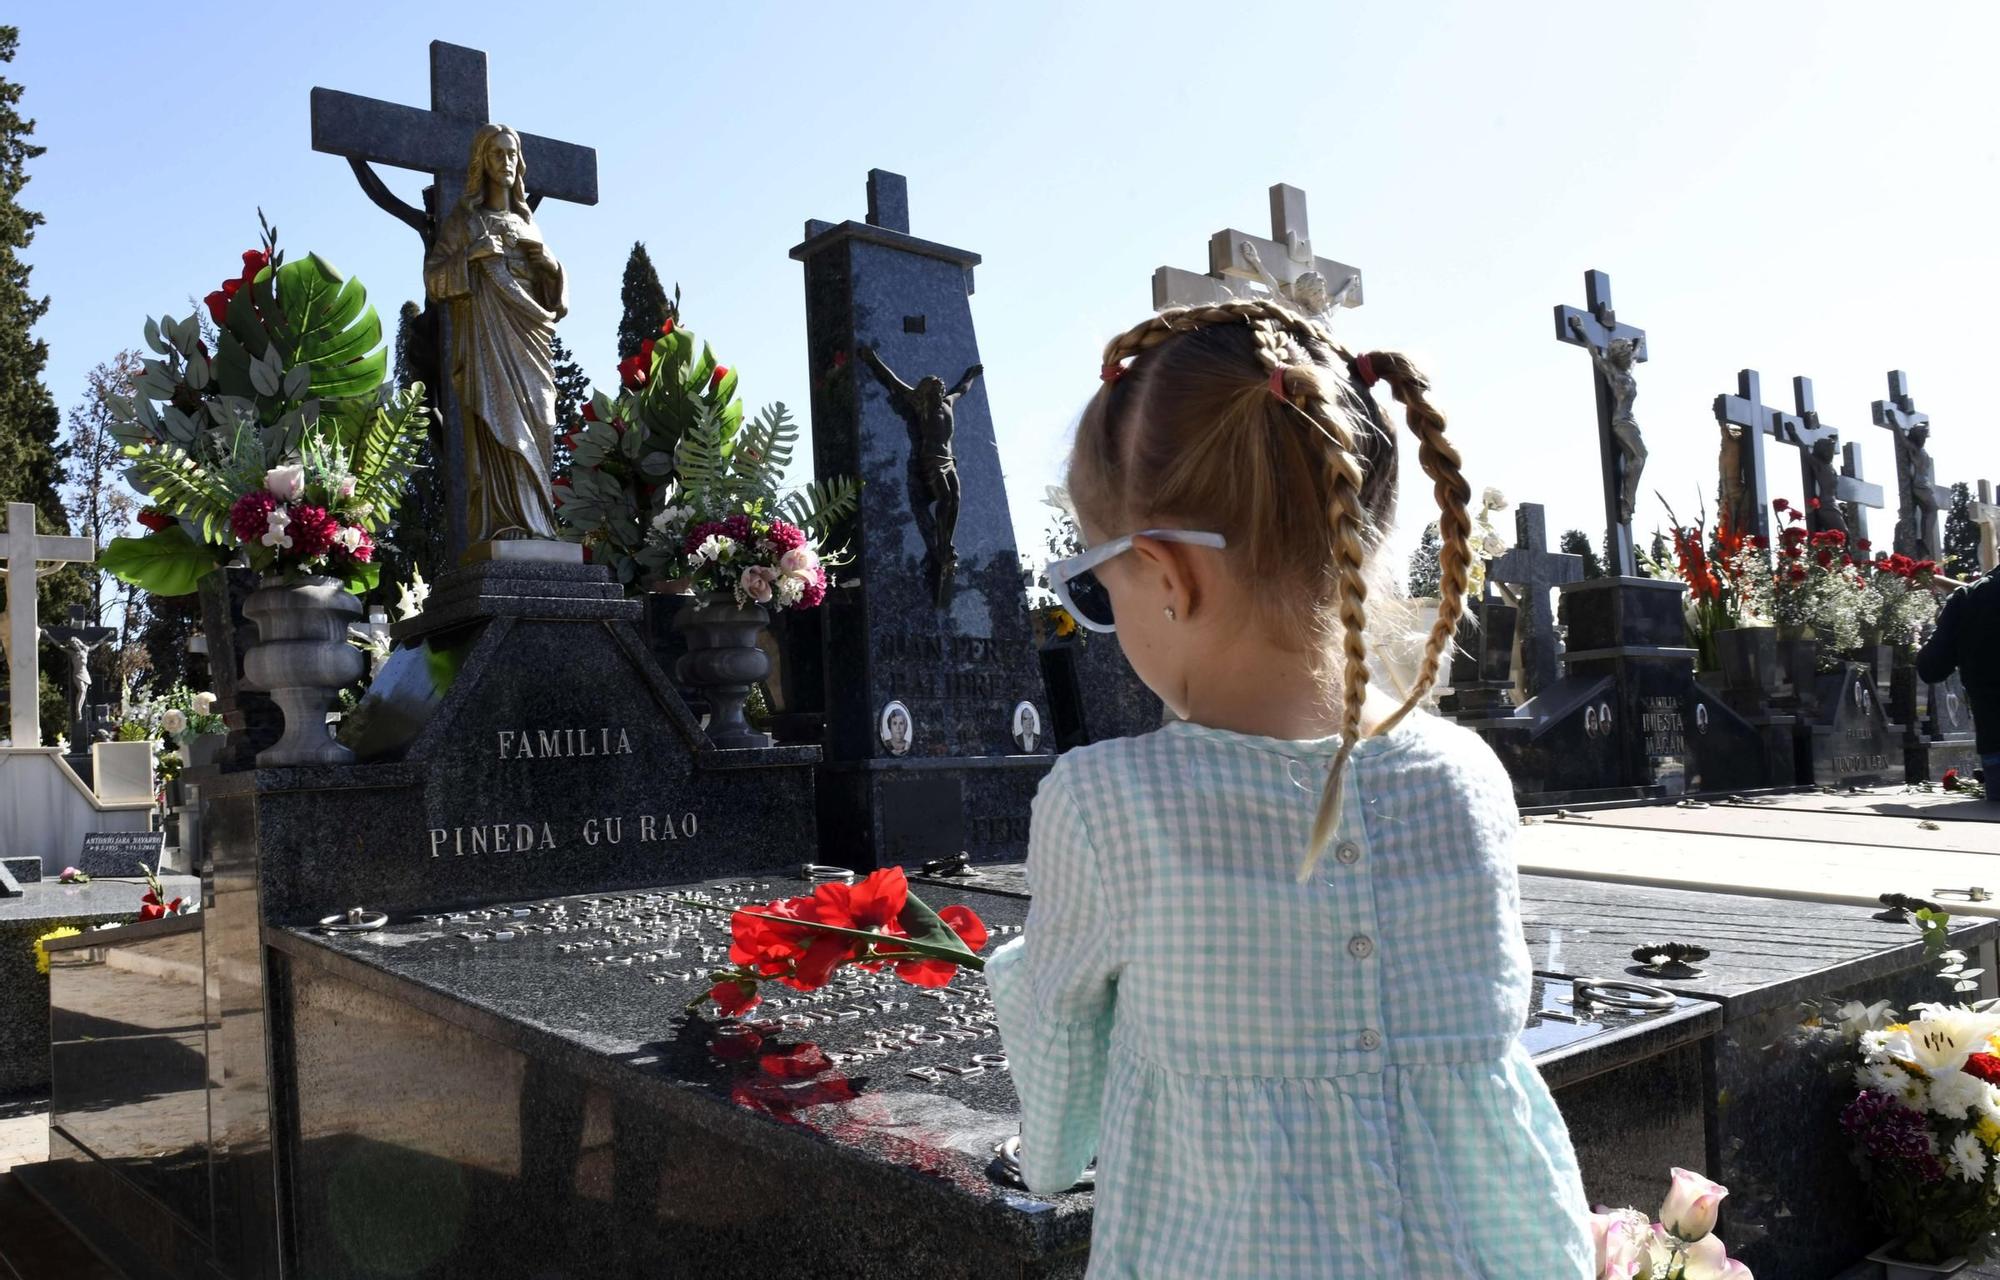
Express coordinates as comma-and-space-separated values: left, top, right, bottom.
312, 40, 598, 562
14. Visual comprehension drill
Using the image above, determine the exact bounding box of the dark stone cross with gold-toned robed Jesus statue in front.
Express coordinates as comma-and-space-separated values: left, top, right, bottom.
312, 40, 598, 560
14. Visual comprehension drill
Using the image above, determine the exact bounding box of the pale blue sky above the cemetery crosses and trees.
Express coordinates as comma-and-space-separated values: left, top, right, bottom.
8, 0, 2000, 568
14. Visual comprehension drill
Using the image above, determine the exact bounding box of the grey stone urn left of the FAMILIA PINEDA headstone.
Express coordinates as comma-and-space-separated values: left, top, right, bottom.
244, 578, 368, 768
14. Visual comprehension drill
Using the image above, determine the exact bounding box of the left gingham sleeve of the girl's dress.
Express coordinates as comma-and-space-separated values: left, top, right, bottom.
986, 774, 1118, 1196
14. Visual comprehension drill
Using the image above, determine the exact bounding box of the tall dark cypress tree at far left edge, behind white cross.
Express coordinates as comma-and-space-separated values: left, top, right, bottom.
0, 26, 90, 746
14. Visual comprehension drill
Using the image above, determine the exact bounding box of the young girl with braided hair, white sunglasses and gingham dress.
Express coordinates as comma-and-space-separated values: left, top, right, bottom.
986, 300, 1596, 1280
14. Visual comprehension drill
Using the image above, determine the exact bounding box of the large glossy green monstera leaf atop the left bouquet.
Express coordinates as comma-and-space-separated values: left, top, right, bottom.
216, 254, 388, 416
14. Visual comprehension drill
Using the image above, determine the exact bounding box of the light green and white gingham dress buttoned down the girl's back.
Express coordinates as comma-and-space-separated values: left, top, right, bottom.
986, 716, 1596, 1280
